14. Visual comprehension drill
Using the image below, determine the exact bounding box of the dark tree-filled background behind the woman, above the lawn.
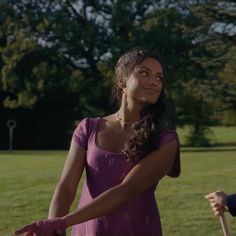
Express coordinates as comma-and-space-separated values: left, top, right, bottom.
0, 0, 236, 150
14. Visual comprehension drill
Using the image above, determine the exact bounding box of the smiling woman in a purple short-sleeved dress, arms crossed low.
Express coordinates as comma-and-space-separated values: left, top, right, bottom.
16, 48, 180, 236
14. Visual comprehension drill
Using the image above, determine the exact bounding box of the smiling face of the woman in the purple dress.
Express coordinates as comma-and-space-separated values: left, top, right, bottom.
123, 58, 163, 105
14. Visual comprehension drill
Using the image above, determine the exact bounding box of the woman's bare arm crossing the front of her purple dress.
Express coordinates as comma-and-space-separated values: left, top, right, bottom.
63, 140, 178, 226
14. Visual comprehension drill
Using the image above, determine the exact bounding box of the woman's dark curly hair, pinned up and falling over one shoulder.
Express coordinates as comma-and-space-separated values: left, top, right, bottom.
112, 48, 166, 159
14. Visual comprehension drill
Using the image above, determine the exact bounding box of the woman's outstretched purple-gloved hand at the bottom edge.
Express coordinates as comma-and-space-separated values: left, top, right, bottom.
15, 217, 67, 236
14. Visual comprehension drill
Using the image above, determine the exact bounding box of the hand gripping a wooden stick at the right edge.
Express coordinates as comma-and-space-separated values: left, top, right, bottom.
205, 191, 228, 216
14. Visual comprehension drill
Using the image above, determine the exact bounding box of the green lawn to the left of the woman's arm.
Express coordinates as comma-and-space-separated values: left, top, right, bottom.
0, 152, 65, 236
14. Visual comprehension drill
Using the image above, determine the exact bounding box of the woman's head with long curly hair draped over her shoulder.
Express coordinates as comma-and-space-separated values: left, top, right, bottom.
113, 48, 165, 159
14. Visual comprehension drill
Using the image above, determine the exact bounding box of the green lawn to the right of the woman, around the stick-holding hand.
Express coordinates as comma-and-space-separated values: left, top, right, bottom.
156, 151, 236, 236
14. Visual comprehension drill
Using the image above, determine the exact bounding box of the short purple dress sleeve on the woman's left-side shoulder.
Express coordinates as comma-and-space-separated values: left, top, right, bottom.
72, 118, 88, 151
